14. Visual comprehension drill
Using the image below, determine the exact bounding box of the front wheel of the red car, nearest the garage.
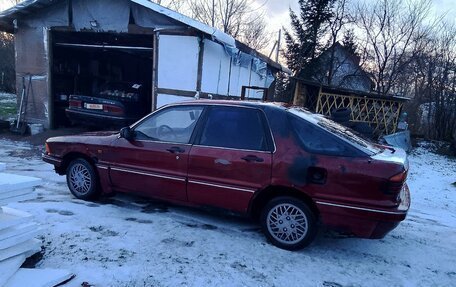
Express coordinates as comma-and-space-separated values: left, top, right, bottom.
66, 158, 99, 200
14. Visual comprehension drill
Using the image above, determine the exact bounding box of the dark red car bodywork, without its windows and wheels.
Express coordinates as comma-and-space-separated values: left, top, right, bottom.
43, 101, 410, 241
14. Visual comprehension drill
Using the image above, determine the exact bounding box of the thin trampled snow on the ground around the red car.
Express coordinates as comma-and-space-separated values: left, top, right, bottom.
0, 140, 456, 286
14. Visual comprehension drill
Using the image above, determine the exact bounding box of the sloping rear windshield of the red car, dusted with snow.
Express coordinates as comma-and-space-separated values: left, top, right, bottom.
288, 108, 383, 155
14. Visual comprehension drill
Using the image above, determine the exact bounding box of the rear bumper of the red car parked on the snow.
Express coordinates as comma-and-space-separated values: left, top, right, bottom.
316, 184, 410, 239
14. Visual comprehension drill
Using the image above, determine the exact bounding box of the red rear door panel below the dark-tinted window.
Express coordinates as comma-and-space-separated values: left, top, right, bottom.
187, 146, 272, 213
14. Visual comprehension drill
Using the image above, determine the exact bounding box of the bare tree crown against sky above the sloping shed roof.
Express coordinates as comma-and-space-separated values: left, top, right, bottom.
189, 0, 270, 50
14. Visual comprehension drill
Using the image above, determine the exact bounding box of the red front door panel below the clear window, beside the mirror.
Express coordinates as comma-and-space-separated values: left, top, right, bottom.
104, 138, 191, 201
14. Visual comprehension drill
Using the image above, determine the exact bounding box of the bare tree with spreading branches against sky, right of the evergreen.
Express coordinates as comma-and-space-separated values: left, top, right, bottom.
357, 0, 431, 95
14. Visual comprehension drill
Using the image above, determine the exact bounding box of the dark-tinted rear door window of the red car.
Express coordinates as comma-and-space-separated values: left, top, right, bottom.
200, 107, 268, 151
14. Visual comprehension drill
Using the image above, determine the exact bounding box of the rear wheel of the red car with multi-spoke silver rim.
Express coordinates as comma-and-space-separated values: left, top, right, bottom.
260, 196, 317, 250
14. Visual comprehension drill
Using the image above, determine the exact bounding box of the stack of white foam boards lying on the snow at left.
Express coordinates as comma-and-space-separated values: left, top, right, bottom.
0, 164, 72, 287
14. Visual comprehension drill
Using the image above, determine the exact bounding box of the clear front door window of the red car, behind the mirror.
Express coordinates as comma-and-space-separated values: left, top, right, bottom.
134, 106, 203, 143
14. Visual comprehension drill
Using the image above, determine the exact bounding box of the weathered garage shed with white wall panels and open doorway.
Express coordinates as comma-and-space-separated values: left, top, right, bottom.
0, 0, 285, 128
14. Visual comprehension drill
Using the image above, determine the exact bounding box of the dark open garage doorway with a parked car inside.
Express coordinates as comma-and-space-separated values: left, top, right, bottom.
50, 31, 154, 128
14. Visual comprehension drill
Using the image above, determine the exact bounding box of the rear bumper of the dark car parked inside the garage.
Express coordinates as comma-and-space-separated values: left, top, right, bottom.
65, 109, 138, 127
